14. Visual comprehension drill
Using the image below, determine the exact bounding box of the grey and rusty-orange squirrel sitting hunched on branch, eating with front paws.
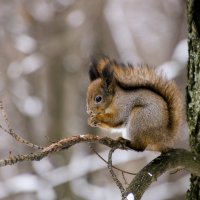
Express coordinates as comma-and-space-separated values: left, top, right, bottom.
87, 57, 183, 152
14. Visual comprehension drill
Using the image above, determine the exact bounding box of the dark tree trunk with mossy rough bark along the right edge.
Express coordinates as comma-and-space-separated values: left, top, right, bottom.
187, 0, 200, 200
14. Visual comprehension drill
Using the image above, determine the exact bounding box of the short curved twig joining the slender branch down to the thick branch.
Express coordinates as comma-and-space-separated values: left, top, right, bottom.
108, 147, 125, 195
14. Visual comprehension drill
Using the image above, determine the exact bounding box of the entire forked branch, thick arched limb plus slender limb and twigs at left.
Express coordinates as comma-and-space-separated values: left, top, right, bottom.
0, 101, 200, 200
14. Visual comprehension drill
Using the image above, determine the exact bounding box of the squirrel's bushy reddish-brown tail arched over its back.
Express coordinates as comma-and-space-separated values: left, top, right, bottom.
113, 65, 183, 140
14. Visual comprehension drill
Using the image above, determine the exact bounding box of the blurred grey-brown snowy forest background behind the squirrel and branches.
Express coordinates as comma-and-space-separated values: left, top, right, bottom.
0, 0, 189, 200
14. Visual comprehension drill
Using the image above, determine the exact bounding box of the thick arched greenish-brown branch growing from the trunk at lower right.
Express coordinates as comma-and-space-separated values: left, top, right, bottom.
122, 149, 200, 200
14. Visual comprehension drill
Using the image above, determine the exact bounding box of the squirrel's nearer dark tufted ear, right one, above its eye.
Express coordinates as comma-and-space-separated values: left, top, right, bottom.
101, 64, 114, 92
